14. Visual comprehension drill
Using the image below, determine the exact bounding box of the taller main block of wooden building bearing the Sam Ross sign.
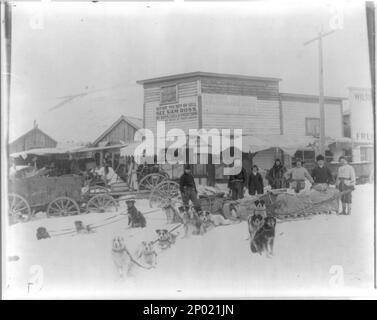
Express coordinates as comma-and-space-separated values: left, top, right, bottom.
137, 72, 281, 184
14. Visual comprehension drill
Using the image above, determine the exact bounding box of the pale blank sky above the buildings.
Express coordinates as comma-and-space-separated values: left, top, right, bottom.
9, 1, 370, 142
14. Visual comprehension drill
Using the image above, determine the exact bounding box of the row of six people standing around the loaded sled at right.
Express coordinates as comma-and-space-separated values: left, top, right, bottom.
228, 155, 356, 214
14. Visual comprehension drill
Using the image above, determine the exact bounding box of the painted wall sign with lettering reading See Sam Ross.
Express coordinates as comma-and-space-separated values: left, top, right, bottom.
156, 102, 198, 122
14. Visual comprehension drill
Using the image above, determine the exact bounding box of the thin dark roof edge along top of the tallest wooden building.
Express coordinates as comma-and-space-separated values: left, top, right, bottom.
136, 71, 282, 84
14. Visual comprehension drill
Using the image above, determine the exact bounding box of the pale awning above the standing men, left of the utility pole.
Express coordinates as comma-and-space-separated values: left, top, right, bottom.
242, 135, 316, 156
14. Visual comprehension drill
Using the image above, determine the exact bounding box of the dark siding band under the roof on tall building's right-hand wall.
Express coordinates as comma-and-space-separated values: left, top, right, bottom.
201, 77, 279, 100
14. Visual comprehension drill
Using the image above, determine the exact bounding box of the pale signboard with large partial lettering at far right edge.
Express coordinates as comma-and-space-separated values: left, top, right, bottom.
349, 88, 373, 143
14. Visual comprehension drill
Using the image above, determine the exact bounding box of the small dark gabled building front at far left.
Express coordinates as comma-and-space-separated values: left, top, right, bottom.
9, 123, 57, 154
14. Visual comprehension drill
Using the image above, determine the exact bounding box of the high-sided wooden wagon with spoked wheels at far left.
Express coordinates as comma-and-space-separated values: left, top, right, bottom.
8, 175, 118, 223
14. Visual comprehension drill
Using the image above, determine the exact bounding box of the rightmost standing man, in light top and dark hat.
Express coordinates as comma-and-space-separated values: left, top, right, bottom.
336, 156, 356, 215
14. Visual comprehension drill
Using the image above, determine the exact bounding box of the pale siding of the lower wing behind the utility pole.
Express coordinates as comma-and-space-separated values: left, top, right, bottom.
282, 100, 343, 138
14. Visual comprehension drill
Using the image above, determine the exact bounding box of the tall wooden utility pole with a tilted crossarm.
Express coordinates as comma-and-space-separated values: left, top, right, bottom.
304, 30, 335, 156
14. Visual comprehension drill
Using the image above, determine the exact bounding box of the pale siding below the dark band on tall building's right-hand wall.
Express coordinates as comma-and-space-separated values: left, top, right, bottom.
202, 93, 280, 134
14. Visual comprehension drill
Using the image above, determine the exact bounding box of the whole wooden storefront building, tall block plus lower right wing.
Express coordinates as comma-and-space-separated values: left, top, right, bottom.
137, 72, 350, 183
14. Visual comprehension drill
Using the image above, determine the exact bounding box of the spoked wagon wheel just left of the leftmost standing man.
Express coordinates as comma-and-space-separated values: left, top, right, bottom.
149, 180, 181, 208
